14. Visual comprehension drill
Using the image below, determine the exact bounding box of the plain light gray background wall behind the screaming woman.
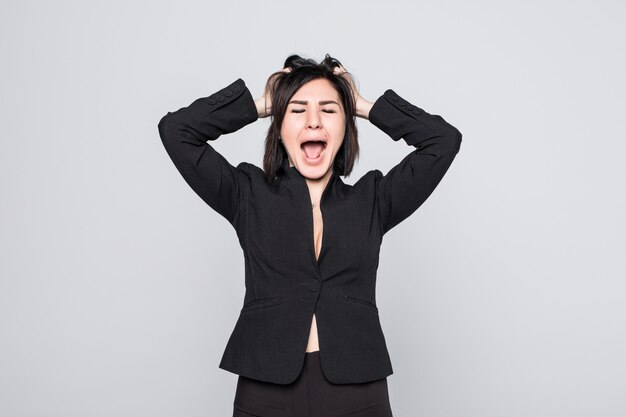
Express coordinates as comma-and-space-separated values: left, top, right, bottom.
0, 0, 626, 417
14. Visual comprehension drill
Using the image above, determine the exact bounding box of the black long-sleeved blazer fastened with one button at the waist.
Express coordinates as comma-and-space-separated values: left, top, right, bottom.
159, 79, 461, 384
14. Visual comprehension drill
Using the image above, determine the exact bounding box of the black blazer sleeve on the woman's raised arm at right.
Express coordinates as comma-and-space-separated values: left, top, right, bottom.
369, 90, 461, 235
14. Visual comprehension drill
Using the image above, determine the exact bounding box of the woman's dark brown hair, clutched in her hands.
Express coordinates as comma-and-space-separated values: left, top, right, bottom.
263, 54, 359, 181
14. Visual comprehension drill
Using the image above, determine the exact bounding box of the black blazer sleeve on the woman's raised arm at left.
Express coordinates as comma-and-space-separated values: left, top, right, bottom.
158, 78, 258, 225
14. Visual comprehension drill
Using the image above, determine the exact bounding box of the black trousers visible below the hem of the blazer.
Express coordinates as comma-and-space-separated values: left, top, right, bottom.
233, 351, 392, 417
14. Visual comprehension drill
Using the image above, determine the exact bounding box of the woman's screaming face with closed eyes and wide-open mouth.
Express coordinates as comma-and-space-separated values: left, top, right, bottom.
280, 78, 346, 179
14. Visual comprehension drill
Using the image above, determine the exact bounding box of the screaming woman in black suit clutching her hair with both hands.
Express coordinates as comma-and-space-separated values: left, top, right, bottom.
159, 55, 461, 417
